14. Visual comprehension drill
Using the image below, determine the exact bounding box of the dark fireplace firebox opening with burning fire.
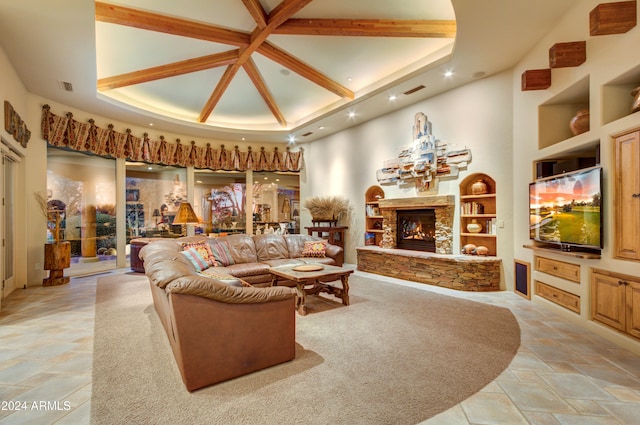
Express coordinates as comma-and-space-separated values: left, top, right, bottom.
396, 208, 436, 252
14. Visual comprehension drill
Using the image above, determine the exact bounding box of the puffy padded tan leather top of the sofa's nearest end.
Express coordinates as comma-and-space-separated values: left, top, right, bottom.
165, 275, 296, 304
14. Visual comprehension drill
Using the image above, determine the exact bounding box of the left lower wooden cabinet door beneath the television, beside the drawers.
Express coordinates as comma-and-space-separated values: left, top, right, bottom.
591, 273, 626, 332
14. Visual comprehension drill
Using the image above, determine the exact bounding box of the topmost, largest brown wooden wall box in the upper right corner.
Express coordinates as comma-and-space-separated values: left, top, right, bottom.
589, 1, 637, 35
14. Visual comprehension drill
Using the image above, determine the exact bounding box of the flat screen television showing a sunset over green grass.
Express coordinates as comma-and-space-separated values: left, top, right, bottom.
529, 166, 603, 251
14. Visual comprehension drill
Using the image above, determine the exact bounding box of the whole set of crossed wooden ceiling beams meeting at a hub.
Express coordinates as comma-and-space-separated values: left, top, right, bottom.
95, 0, 456, 127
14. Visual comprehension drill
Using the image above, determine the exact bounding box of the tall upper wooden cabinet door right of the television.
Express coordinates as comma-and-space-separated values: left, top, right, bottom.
614, 131, 640, 261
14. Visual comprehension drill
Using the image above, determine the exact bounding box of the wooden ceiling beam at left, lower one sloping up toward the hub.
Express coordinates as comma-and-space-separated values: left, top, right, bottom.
98, 49, 239, 91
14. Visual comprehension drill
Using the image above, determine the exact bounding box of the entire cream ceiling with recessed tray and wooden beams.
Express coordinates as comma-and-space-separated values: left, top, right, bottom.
0, 0, 572, 142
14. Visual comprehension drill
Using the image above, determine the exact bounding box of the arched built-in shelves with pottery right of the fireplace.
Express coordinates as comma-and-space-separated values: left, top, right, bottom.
460, 173, 497, 256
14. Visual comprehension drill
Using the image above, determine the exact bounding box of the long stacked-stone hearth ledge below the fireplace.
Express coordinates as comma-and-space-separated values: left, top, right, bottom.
356, 246, 502, 292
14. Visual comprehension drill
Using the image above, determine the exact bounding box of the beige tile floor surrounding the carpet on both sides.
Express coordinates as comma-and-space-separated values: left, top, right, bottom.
0, 270, 640, 425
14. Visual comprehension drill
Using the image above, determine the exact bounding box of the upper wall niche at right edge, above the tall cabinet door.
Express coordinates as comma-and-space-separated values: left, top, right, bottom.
602, 65, 640, 124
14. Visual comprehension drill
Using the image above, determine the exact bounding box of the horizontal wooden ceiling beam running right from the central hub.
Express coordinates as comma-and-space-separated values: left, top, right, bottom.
273, 19, 456, 38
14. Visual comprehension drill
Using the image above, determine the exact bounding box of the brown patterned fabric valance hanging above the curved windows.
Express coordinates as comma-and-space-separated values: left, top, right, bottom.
42, 105, 303, 172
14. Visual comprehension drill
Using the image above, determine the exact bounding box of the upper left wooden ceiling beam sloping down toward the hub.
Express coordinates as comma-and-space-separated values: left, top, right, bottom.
95, 2, 250, 46
